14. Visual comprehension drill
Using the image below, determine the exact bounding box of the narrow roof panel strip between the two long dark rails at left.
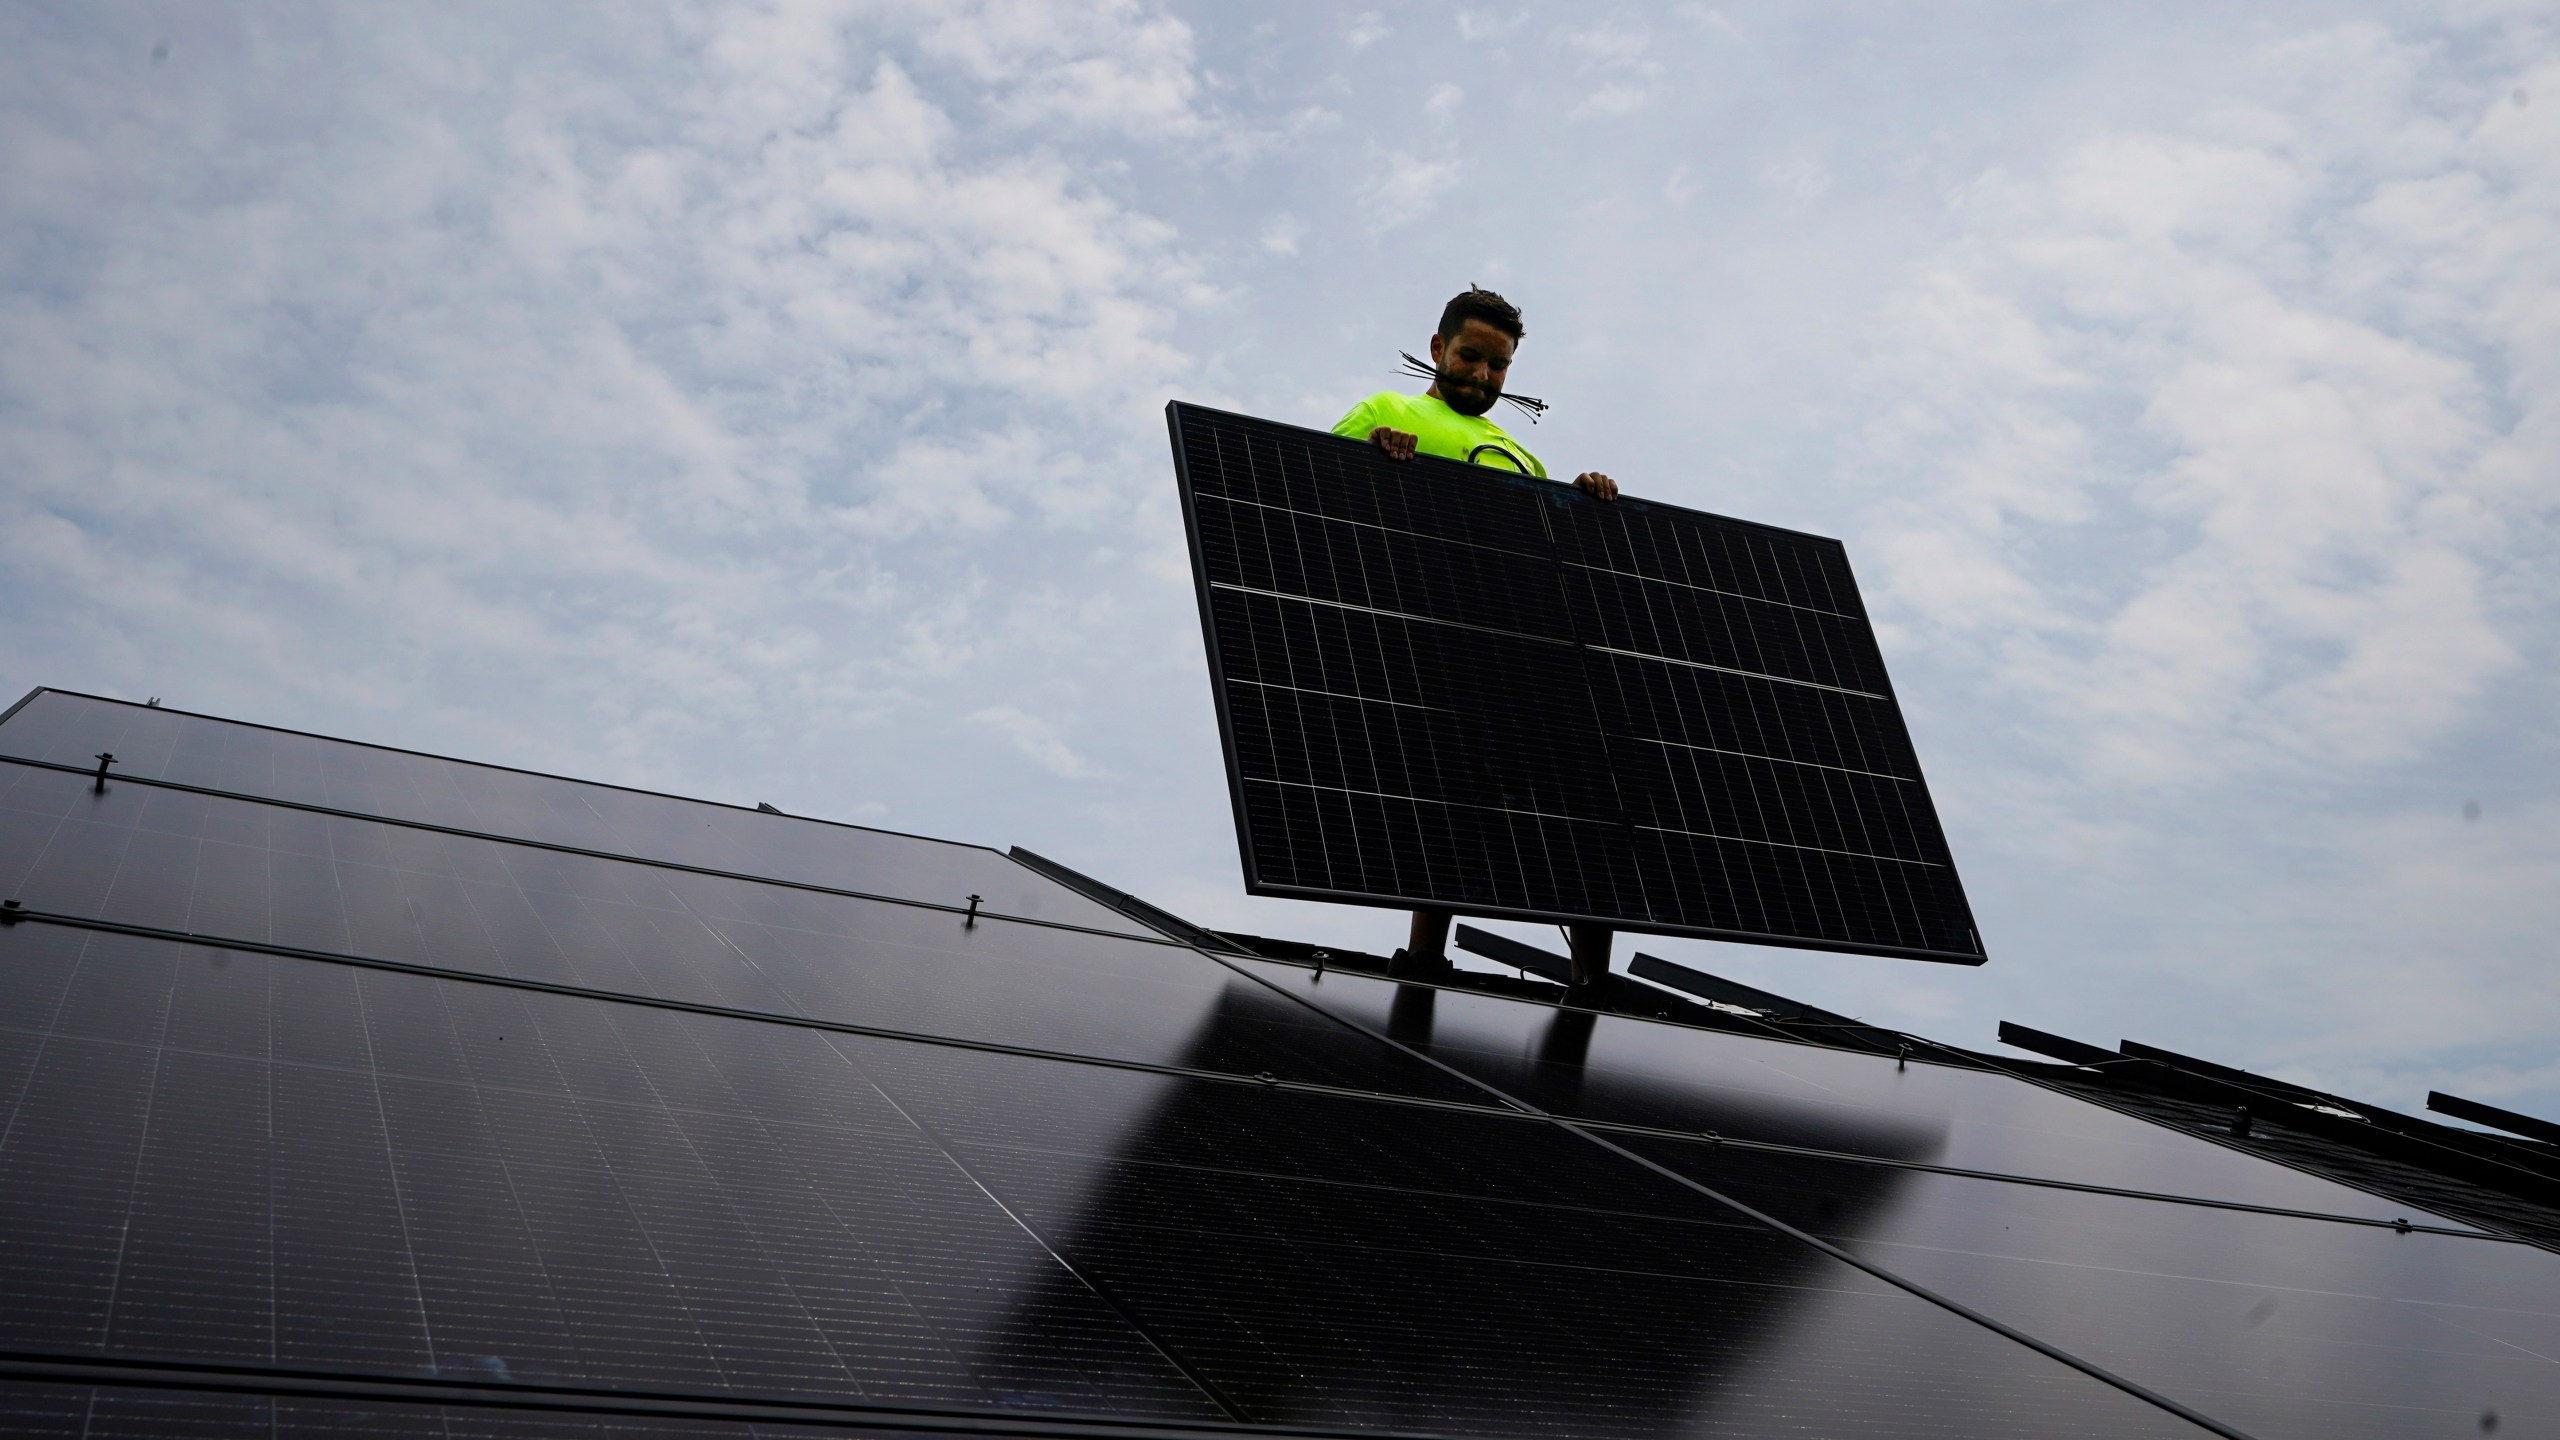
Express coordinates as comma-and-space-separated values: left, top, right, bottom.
0, 761, 1464, 1099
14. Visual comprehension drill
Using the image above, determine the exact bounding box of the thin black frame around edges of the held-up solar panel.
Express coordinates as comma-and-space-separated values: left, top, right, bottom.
1165, 400, 1989, 966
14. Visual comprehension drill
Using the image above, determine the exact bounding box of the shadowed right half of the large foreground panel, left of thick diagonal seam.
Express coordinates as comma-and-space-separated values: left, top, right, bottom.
844, 1030, 2222, 1435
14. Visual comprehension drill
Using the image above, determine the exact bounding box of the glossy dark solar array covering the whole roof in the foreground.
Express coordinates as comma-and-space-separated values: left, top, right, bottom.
0, 697, 2560, 1440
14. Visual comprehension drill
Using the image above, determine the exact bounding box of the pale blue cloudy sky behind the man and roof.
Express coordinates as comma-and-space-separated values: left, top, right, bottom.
0, 0, 2560, 1117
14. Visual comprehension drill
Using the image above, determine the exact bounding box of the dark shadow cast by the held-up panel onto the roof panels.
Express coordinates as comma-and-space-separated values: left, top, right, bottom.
965, 989, 1933, 1435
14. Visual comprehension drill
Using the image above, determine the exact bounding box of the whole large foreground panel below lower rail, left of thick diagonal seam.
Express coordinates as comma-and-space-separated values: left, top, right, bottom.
0, 925, 2181, 1437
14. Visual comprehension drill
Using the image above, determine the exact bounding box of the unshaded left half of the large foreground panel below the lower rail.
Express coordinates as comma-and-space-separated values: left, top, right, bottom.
0, 925, 1219, 1417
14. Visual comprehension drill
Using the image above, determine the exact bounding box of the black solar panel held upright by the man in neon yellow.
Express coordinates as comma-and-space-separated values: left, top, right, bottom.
1167, 402, 1984, 963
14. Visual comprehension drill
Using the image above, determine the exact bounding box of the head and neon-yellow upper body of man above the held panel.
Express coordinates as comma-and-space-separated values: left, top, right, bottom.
1334, 284, 1618, 500
